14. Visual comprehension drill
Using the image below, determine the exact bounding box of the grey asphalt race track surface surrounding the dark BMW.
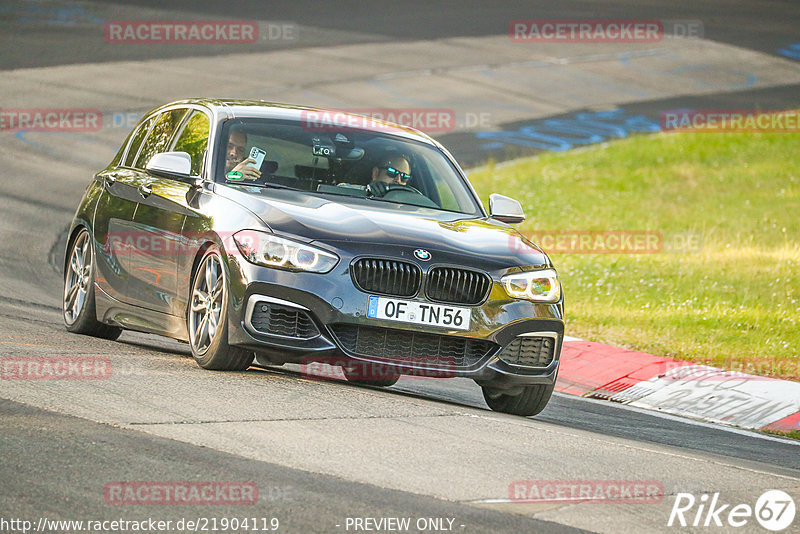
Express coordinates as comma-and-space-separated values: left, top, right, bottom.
0, 0, 800, 533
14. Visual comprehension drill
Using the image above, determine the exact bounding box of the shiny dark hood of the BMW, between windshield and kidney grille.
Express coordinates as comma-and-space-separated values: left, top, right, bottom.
216, 186, 550, 269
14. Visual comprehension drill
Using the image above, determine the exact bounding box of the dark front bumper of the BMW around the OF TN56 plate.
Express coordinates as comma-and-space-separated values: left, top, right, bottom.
223, 253, 564, 390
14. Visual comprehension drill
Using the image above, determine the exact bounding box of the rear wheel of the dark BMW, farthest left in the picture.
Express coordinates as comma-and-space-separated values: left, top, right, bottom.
61, 228, 122, 341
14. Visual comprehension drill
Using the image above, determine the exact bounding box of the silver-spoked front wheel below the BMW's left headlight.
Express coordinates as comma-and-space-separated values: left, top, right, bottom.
186, 247, 255, 371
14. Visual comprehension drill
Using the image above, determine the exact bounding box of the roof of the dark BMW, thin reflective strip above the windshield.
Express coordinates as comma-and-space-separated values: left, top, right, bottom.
161, 98, 440, 146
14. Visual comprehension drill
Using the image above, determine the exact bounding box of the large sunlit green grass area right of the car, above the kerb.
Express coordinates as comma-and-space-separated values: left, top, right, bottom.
470, 129, 800, 380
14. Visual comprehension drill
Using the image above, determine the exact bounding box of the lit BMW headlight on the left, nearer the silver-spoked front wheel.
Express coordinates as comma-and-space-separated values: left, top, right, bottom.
233, 230, 339, 273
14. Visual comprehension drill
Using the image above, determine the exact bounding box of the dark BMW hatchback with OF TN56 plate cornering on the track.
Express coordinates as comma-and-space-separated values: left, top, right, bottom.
63, 99, 564, 415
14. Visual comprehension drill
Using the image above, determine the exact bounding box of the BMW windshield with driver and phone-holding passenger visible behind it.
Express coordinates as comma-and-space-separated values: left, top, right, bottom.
215, 119, 480, 215
